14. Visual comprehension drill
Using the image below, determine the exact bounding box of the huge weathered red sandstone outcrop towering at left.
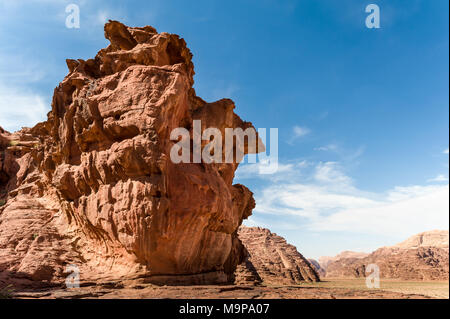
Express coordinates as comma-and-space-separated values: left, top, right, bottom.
0, 21, 262, 284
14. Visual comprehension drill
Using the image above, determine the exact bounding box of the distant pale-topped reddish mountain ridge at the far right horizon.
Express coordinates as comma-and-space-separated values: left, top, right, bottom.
326, 231, 449, 281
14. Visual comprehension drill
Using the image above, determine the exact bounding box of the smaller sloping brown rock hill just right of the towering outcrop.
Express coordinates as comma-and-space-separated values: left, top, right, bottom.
235, 226, 319, 285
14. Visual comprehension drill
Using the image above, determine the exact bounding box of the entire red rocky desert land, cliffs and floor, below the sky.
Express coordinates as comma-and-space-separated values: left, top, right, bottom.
0, 21, 449, 299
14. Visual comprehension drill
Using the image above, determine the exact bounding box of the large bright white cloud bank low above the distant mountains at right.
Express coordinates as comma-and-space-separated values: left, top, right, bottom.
251, 162, 449, 236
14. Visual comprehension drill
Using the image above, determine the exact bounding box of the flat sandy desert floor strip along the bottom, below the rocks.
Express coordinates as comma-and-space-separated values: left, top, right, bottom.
6, 279, 449, 299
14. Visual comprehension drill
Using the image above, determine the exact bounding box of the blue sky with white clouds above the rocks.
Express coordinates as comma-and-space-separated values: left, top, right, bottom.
0, 0, 449, 257
